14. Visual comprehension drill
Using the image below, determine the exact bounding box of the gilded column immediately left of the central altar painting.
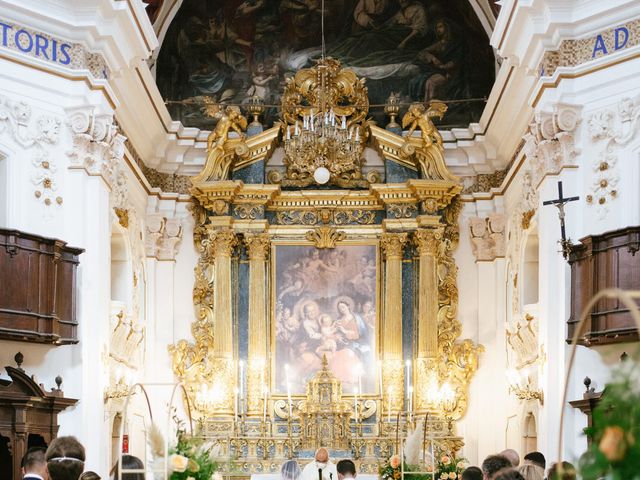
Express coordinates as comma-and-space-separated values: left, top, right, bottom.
245, 233, 270, 414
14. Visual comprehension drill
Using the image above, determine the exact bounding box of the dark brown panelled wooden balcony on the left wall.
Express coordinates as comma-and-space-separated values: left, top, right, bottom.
0, 229, 84, 345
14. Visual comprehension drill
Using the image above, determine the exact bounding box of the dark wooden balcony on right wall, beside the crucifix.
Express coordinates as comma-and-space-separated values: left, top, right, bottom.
567, 227, 640, 346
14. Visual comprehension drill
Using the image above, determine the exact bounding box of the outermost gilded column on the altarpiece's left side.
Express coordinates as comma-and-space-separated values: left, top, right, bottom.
208, 228, 238, 414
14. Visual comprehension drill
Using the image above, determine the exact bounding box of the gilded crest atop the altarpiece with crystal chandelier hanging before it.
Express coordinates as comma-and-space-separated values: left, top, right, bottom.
282, 58, 368, 187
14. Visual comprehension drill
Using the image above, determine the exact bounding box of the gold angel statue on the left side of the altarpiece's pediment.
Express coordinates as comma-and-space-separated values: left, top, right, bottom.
204, 97, 247, 180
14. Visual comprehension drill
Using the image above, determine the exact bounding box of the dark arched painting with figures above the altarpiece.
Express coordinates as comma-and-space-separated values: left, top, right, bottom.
156, 0, 495, 129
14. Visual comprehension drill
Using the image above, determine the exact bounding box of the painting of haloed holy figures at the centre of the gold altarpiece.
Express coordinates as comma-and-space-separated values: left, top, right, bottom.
271, 241, 380, 395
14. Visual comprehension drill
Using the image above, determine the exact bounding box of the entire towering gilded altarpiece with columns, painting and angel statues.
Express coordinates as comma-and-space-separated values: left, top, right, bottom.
169, 62, 481, 473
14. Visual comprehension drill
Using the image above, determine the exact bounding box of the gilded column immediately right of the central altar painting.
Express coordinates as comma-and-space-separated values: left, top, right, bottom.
380, 233, 408, 415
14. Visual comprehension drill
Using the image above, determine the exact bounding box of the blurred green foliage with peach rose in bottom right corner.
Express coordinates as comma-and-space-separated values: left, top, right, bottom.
578, 359, 640, 480
